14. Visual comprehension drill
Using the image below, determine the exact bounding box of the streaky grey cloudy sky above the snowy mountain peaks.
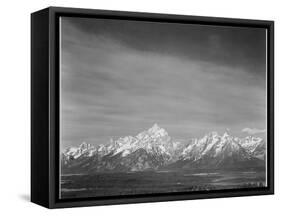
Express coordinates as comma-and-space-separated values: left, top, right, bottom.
60, 17, 266, 150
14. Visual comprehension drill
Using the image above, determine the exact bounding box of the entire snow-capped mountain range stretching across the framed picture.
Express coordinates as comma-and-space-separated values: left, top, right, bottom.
61, 124, 266, 173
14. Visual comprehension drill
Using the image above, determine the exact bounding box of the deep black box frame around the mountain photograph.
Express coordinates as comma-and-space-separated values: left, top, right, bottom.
31, 7, 274, 208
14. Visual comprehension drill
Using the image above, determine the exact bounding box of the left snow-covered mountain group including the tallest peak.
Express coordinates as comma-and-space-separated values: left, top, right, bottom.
62, 124, 173, 171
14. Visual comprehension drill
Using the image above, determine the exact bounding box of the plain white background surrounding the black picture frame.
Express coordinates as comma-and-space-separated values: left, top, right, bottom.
0, 0, 276, 216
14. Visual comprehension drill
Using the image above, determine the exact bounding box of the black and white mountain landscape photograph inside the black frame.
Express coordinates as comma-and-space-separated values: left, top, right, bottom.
59, 16, 268, 199
